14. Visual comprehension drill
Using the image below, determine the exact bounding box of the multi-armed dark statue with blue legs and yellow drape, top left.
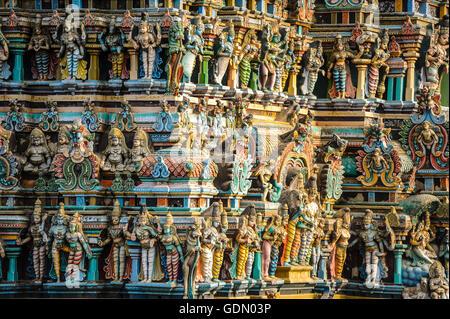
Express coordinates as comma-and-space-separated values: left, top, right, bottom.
54, 14, 87, 80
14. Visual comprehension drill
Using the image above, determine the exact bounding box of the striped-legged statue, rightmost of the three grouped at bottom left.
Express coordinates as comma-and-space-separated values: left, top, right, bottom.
66, 212, 92, 283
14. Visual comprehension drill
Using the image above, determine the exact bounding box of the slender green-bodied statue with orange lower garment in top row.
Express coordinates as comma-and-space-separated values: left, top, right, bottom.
165, 15, 188, 95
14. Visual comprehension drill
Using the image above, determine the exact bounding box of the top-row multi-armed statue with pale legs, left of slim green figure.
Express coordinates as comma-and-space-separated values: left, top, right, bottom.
129, 13, 161, 79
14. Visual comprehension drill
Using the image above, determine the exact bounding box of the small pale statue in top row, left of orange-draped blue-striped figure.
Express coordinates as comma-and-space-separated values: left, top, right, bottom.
302, 41, 325, 95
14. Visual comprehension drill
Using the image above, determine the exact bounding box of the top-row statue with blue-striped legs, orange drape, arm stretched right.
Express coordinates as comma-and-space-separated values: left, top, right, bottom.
327, 34, 361, 99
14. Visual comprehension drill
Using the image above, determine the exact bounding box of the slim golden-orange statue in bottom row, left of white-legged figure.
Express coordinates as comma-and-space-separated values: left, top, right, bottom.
329, 208, 351, 281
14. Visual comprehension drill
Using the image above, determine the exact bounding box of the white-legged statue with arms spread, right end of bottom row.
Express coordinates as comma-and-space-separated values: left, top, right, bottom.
348, 209, 384, 288
